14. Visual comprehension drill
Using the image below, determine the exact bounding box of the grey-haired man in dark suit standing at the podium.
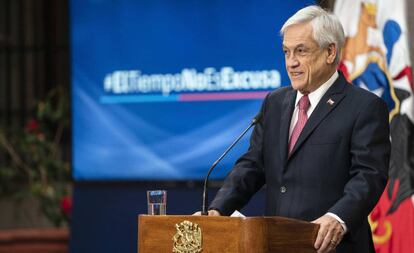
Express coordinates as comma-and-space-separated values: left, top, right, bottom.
209, 6, 390, 253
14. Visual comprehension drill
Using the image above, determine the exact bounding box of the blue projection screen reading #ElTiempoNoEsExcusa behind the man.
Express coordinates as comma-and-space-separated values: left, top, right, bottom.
70, 0, 311, 180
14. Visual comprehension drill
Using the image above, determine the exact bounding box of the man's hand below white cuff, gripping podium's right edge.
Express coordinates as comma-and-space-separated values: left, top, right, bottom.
312, 215, 345, 253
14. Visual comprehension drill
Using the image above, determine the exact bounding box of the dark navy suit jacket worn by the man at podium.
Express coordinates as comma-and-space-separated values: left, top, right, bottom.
210, 73, 390, 253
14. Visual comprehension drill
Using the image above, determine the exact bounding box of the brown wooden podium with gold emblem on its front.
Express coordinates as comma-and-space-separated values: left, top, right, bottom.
138, 215, 319, 253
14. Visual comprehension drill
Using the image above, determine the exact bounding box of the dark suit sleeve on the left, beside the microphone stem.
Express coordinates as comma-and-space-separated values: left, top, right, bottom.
209, 98, 267, 215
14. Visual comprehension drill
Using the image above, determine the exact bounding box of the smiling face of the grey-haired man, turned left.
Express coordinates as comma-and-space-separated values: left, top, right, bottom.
283, 22, 336, 94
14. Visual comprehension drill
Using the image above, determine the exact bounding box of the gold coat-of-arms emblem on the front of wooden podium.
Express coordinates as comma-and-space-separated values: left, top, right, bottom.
173, 220, 203, 253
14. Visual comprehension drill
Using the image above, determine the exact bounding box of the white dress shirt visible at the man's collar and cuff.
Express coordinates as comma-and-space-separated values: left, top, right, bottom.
289, 71, 347, 232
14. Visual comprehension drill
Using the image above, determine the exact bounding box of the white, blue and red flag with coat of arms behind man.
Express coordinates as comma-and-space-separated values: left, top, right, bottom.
334, 0, 414, 253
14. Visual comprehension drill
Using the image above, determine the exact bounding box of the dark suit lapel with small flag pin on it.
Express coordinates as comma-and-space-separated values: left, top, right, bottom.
288, 75, 347, 161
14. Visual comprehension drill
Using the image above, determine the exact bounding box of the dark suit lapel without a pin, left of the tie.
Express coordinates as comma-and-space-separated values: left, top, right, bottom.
279, 89, 296, 164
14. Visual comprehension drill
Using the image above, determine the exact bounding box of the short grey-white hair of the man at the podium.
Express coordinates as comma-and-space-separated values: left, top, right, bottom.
280, 5, 345, 64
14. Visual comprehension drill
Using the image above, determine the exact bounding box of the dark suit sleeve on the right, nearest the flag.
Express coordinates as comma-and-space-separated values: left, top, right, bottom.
329, 97, 391, 233
